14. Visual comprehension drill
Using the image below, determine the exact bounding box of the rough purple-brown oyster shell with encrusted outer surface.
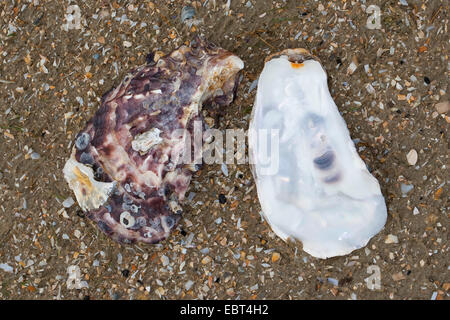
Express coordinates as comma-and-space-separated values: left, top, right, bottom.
64, 38, 244, 243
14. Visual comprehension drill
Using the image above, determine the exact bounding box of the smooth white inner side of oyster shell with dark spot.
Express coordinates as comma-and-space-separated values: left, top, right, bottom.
249, 49, 387, 258
